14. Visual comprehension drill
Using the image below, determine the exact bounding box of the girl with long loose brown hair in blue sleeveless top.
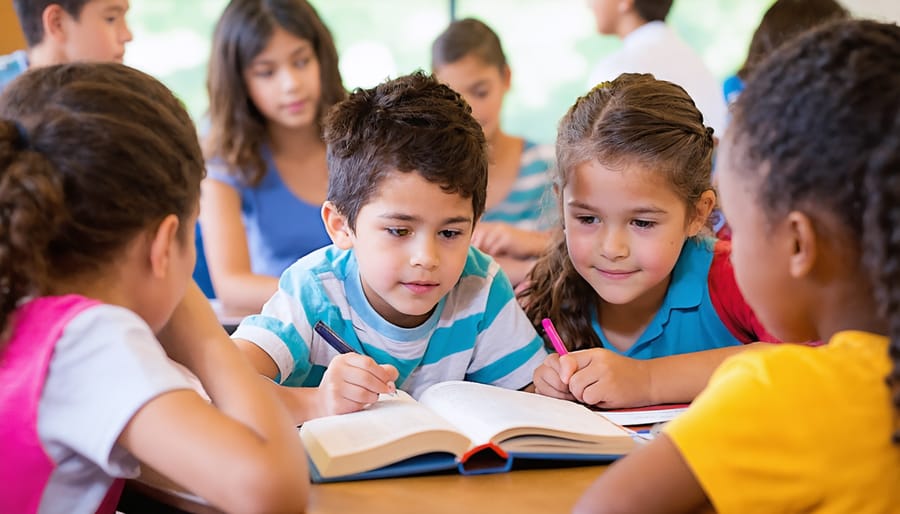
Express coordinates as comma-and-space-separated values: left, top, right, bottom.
200, 0, 346, 312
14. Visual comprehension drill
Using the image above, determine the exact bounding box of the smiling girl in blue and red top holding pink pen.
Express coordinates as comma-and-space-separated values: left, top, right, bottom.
521, 74, 770, 407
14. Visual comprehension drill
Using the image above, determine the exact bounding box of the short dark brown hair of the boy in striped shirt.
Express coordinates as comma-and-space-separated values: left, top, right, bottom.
325, 71, 488, 229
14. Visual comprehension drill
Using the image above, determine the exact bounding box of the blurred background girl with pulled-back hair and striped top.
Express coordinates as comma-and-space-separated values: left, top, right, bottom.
431, 18, 555, 285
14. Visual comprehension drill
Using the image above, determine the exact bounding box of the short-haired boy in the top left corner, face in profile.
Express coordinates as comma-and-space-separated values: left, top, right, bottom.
0, 0, 131, 91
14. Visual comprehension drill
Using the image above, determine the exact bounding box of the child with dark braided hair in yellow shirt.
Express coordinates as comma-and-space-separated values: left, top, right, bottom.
576, 20, 900, 513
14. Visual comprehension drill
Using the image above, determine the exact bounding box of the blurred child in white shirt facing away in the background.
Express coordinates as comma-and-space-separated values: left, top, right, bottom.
588, 0, 725, 136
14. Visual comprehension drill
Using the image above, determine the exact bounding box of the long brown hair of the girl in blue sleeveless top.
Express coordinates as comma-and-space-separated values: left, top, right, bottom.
203, 0, 347, 185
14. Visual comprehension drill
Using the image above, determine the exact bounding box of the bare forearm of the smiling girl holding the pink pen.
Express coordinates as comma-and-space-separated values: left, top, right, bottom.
647, 343, 765, 404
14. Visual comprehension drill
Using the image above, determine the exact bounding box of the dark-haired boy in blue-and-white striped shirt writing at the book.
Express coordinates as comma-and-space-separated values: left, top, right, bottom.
233, 72, 546, 422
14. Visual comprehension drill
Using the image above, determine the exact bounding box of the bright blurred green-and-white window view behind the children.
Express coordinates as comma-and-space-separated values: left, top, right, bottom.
126, 0, 773, 143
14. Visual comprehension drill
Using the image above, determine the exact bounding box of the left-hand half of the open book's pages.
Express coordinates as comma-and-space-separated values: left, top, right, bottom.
300, 391, 470, 477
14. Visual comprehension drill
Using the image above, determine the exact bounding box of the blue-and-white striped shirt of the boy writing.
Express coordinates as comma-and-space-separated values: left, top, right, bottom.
233, 245, 547, 397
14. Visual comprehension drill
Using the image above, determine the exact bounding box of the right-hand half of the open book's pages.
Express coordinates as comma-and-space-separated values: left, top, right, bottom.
419, 381, 631, 445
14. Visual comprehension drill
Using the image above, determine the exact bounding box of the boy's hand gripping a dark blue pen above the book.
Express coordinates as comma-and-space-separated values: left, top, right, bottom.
313, 321, 399, 415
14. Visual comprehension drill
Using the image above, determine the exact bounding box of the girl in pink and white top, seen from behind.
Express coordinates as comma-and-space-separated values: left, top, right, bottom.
0, 63, 309, 513
